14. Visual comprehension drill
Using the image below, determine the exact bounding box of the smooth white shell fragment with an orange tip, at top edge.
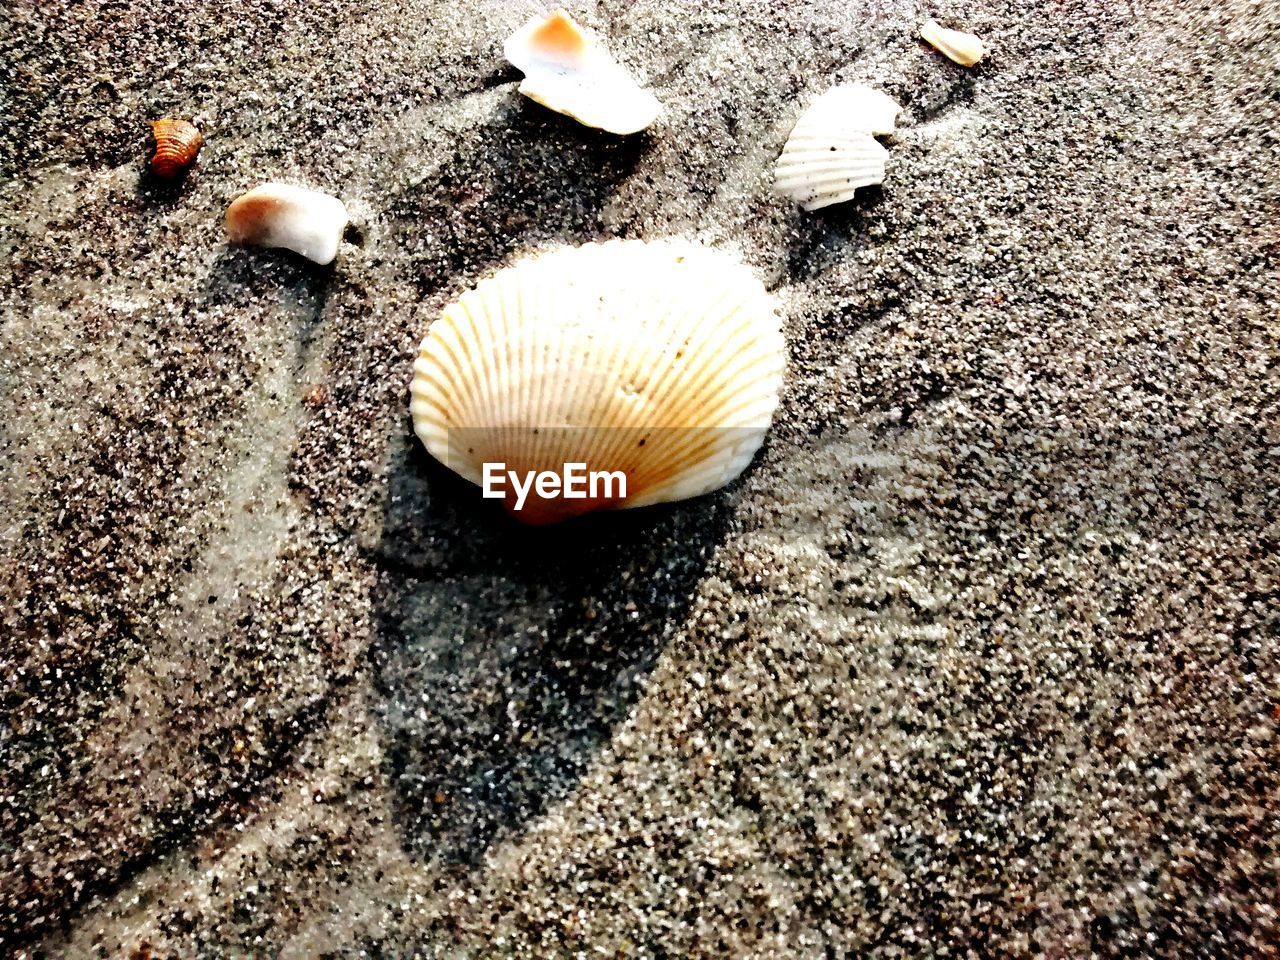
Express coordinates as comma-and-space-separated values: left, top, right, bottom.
503, 10, 662, 134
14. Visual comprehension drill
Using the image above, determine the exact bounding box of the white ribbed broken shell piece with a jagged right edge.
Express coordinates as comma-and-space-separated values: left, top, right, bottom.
774, 83, 901, 210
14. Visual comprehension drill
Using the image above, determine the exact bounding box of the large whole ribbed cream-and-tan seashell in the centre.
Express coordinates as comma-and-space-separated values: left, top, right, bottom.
410, 241, 786, 524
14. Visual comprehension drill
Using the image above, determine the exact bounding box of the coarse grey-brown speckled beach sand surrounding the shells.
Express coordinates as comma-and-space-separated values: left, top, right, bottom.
0, 0, 1280, 957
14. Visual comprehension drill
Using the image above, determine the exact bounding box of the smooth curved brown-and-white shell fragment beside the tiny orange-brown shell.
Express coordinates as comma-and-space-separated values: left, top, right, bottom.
227, 183, 348, 264
